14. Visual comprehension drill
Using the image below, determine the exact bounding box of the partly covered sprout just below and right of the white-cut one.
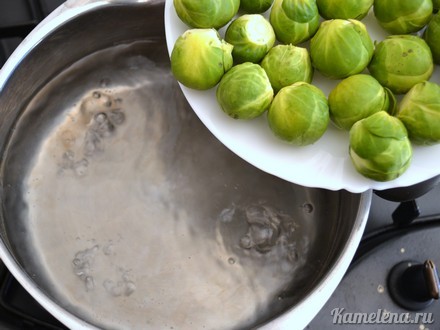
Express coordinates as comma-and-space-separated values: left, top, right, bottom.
260, 45, 313, 93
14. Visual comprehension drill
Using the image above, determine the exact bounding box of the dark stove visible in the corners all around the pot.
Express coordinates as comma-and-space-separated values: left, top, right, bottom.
0, 0, 440, 330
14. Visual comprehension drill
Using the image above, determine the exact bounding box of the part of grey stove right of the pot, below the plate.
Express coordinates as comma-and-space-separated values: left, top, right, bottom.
306, 185, 440, 330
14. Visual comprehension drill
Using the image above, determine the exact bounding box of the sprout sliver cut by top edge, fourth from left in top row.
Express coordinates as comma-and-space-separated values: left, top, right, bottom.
316, 0, 374, 20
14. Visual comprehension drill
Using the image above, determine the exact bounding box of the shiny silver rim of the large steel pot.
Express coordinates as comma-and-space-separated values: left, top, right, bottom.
0, 0, 372, 329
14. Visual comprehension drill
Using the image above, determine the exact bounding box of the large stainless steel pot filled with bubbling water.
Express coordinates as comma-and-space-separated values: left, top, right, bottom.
0, 0, 371, 329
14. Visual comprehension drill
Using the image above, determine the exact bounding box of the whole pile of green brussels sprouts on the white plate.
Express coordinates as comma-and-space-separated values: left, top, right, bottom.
171, 0, 440, 181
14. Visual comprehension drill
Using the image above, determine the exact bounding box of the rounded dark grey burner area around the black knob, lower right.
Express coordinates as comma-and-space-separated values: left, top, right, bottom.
307, 217, 440, 330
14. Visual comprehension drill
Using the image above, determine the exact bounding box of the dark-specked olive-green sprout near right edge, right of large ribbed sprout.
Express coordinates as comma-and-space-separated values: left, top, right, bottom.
368, 35, 434, 94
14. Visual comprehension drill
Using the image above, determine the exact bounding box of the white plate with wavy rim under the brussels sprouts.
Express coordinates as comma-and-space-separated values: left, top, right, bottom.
165, 0, 440, 193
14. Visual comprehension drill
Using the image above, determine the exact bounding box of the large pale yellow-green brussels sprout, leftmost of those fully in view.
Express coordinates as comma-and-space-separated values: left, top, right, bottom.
171, 29, 233, 90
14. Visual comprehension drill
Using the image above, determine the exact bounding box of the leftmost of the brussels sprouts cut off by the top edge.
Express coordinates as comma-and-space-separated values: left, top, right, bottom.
173, 0, 240, 29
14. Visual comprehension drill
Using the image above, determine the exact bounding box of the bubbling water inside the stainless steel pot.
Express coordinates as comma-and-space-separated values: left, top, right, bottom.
13, 42, 316, 329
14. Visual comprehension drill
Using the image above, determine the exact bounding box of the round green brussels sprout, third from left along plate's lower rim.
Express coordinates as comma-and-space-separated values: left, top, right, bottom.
267, 82, 330, 146
